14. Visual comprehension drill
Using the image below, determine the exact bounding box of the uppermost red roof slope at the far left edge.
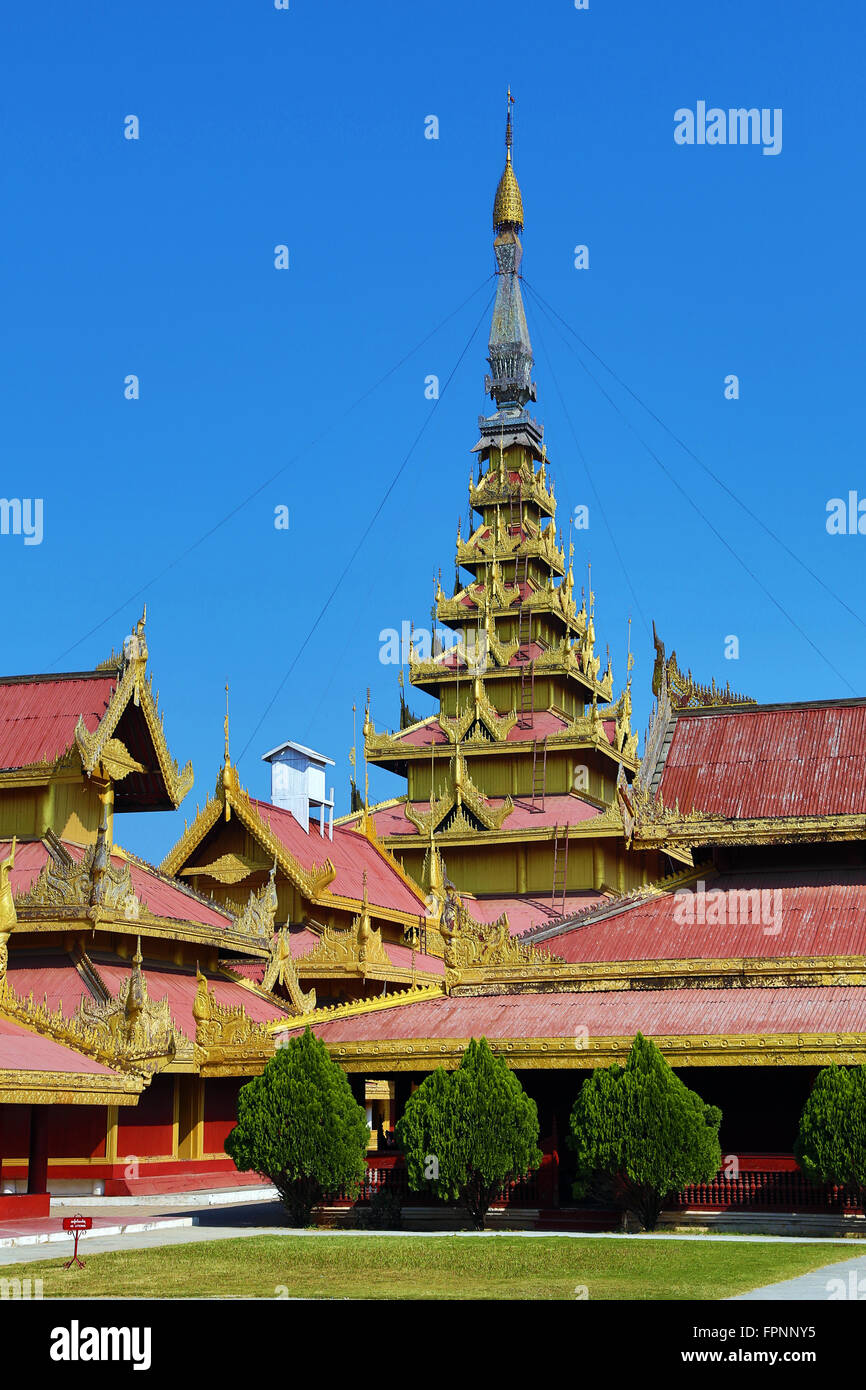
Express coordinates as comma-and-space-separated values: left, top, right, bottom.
0, 671, 115, 769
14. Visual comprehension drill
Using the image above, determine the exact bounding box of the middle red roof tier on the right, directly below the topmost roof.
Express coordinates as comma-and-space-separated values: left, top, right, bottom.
542, 867, 866, 963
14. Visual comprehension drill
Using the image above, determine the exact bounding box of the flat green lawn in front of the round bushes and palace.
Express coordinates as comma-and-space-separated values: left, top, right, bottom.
0, 1236, 859, 1300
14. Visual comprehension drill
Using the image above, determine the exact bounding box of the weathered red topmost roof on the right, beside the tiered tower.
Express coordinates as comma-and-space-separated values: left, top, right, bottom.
660, 705, 866, 819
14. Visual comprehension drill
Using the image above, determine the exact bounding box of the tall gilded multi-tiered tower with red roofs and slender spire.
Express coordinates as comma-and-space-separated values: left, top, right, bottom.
361, 105, 669, 931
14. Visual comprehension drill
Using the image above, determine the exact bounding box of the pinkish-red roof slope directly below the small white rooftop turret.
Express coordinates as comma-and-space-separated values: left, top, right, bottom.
253, 799, 425, 916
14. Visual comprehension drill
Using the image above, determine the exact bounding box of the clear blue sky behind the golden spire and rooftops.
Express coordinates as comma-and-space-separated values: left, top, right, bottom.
0, 0, 866, 859
